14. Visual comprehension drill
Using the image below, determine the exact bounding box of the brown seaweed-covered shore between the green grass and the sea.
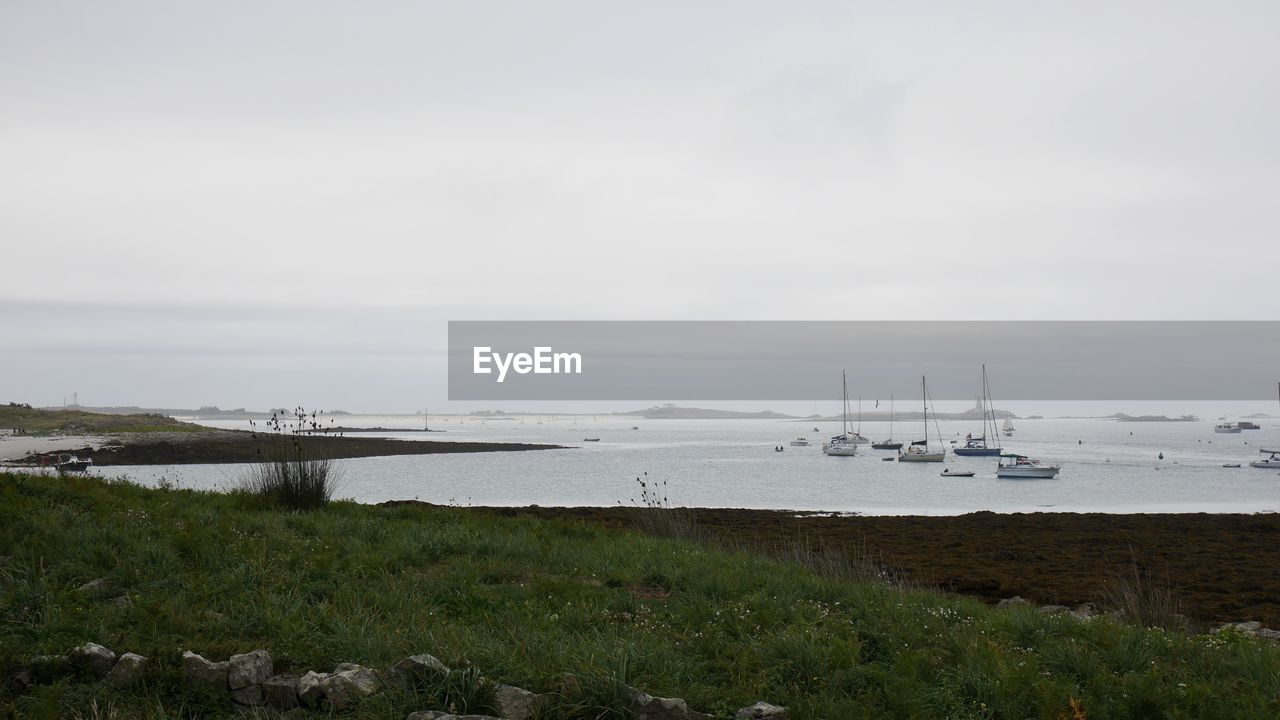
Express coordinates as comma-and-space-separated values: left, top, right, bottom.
448, 506, 1280, 628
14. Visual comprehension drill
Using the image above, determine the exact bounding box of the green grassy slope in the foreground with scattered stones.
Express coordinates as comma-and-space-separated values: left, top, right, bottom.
0, 474, 1280, 720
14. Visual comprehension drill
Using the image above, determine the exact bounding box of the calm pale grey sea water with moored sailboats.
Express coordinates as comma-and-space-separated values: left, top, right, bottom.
90, 415, 1280, 515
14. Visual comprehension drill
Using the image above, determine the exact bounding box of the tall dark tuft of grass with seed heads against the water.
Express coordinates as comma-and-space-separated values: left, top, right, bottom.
242, 407, 340, 510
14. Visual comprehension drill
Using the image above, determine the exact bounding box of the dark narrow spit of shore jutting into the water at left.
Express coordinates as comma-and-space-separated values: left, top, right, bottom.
10, 430, 562, 466
